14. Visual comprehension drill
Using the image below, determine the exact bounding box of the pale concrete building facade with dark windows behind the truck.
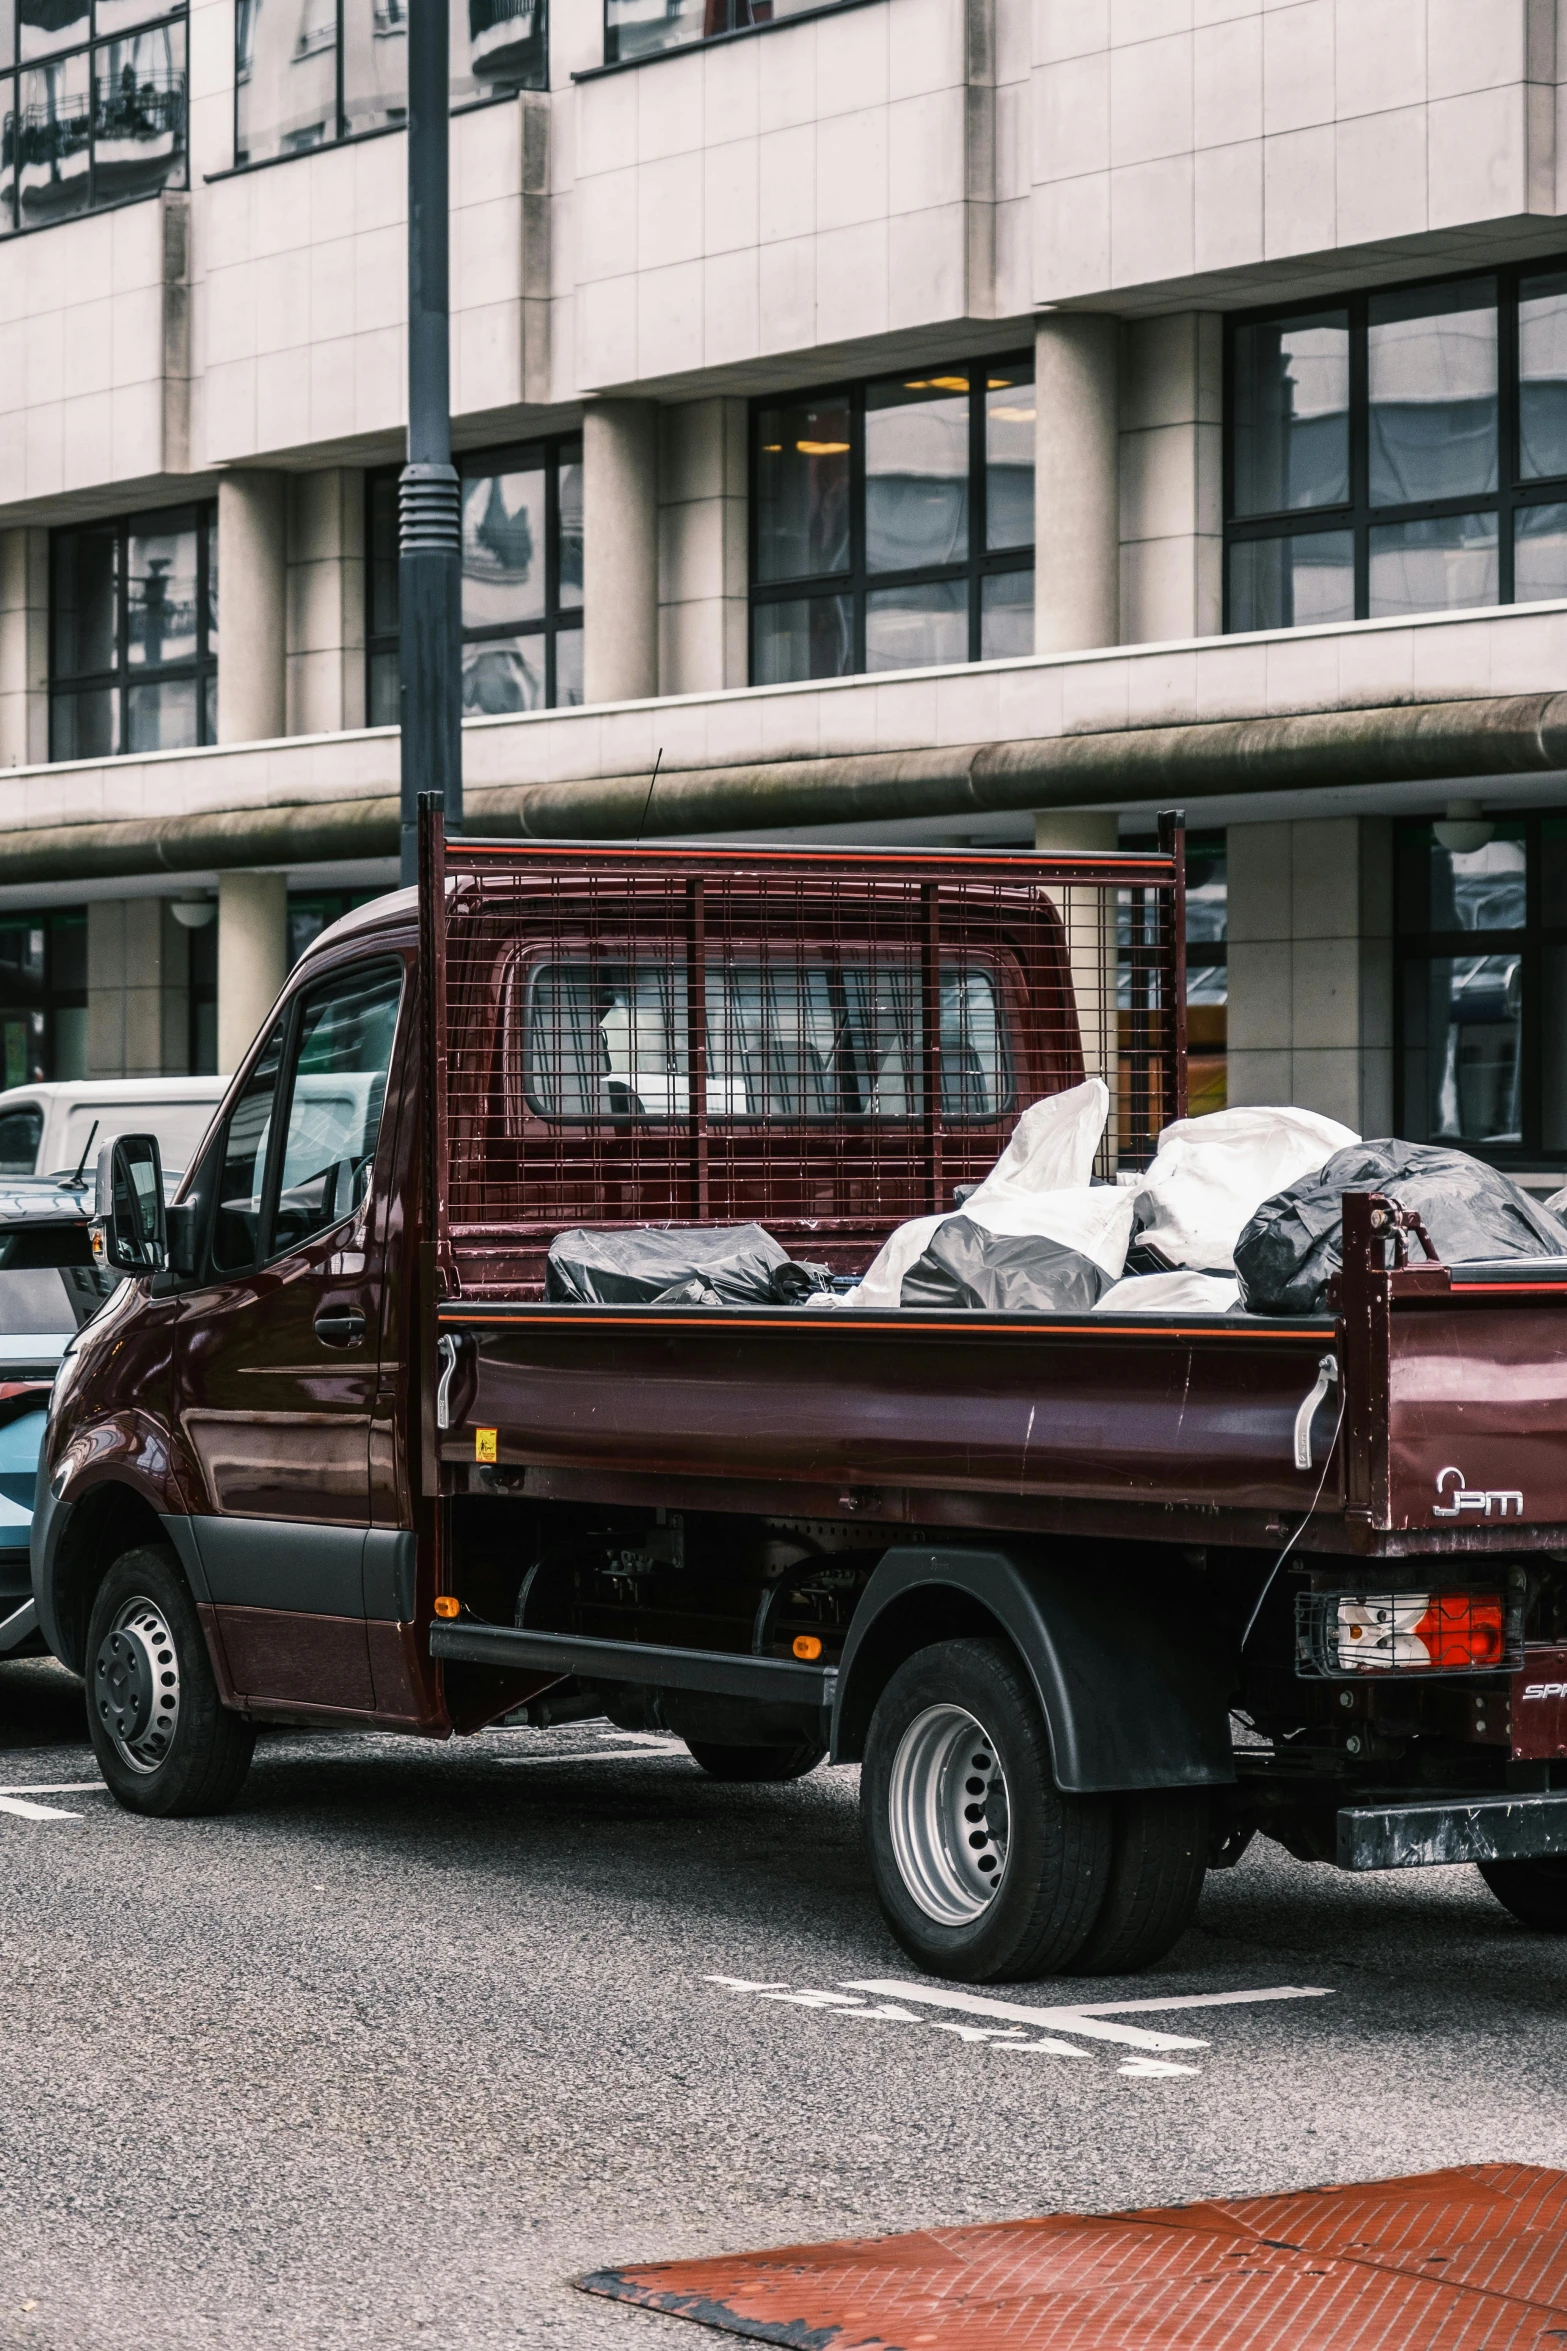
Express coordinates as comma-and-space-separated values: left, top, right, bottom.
0, 0, 1567, 1176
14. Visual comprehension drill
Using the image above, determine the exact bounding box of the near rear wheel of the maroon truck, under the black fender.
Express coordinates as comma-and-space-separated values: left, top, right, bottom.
860, 1641, 1114, 1984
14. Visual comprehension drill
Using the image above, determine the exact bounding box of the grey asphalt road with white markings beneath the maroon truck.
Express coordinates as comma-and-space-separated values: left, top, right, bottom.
0, 1662, 1567, 2351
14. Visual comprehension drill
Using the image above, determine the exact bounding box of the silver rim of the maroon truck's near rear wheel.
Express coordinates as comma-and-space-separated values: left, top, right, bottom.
888, 1707, 1010, 1925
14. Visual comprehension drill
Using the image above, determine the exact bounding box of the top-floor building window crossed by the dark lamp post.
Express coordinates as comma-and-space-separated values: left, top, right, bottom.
234, 0, 550, 165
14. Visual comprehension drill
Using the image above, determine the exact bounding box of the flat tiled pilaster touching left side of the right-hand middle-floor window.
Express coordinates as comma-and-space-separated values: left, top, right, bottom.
1121, 310, 1224, 644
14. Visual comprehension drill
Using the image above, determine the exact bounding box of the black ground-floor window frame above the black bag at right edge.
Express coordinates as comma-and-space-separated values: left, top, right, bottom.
1393, 809, 1567, 1168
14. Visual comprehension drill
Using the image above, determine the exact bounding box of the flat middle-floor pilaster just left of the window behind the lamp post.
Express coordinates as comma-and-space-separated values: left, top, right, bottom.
284, 465, 364, 734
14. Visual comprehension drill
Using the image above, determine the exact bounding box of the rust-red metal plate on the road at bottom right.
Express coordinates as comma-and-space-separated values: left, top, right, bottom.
578, 2163, 1567, 2351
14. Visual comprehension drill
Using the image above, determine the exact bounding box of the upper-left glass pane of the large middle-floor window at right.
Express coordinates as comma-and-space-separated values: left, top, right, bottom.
1231, 310, 1349, 515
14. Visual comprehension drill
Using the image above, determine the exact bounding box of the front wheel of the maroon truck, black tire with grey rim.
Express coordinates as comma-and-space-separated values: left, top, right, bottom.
87, 1542, 256, 1820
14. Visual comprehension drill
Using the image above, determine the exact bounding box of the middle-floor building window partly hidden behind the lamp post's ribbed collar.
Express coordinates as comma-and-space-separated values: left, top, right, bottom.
364, 440, 583, 726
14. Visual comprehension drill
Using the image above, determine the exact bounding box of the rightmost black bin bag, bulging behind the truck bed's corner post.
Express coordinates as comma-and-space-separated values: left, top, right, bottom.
1236, 1140, 1567, 1314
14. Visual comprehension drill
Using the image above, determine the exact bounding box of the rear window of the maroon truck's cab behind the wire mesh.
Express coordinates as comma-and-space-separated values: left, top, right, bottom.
510, 957, 1015, 1124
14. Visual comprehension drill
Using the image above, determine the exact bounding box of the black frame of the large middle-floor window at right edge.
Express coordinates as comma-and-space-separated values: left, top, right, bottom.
1222, 254, 1567, 635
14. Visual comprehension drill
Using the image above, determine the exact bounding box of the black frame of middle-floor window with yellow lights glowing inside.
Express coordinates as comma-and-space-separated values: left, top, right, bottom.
745, 350, 1038, 686
